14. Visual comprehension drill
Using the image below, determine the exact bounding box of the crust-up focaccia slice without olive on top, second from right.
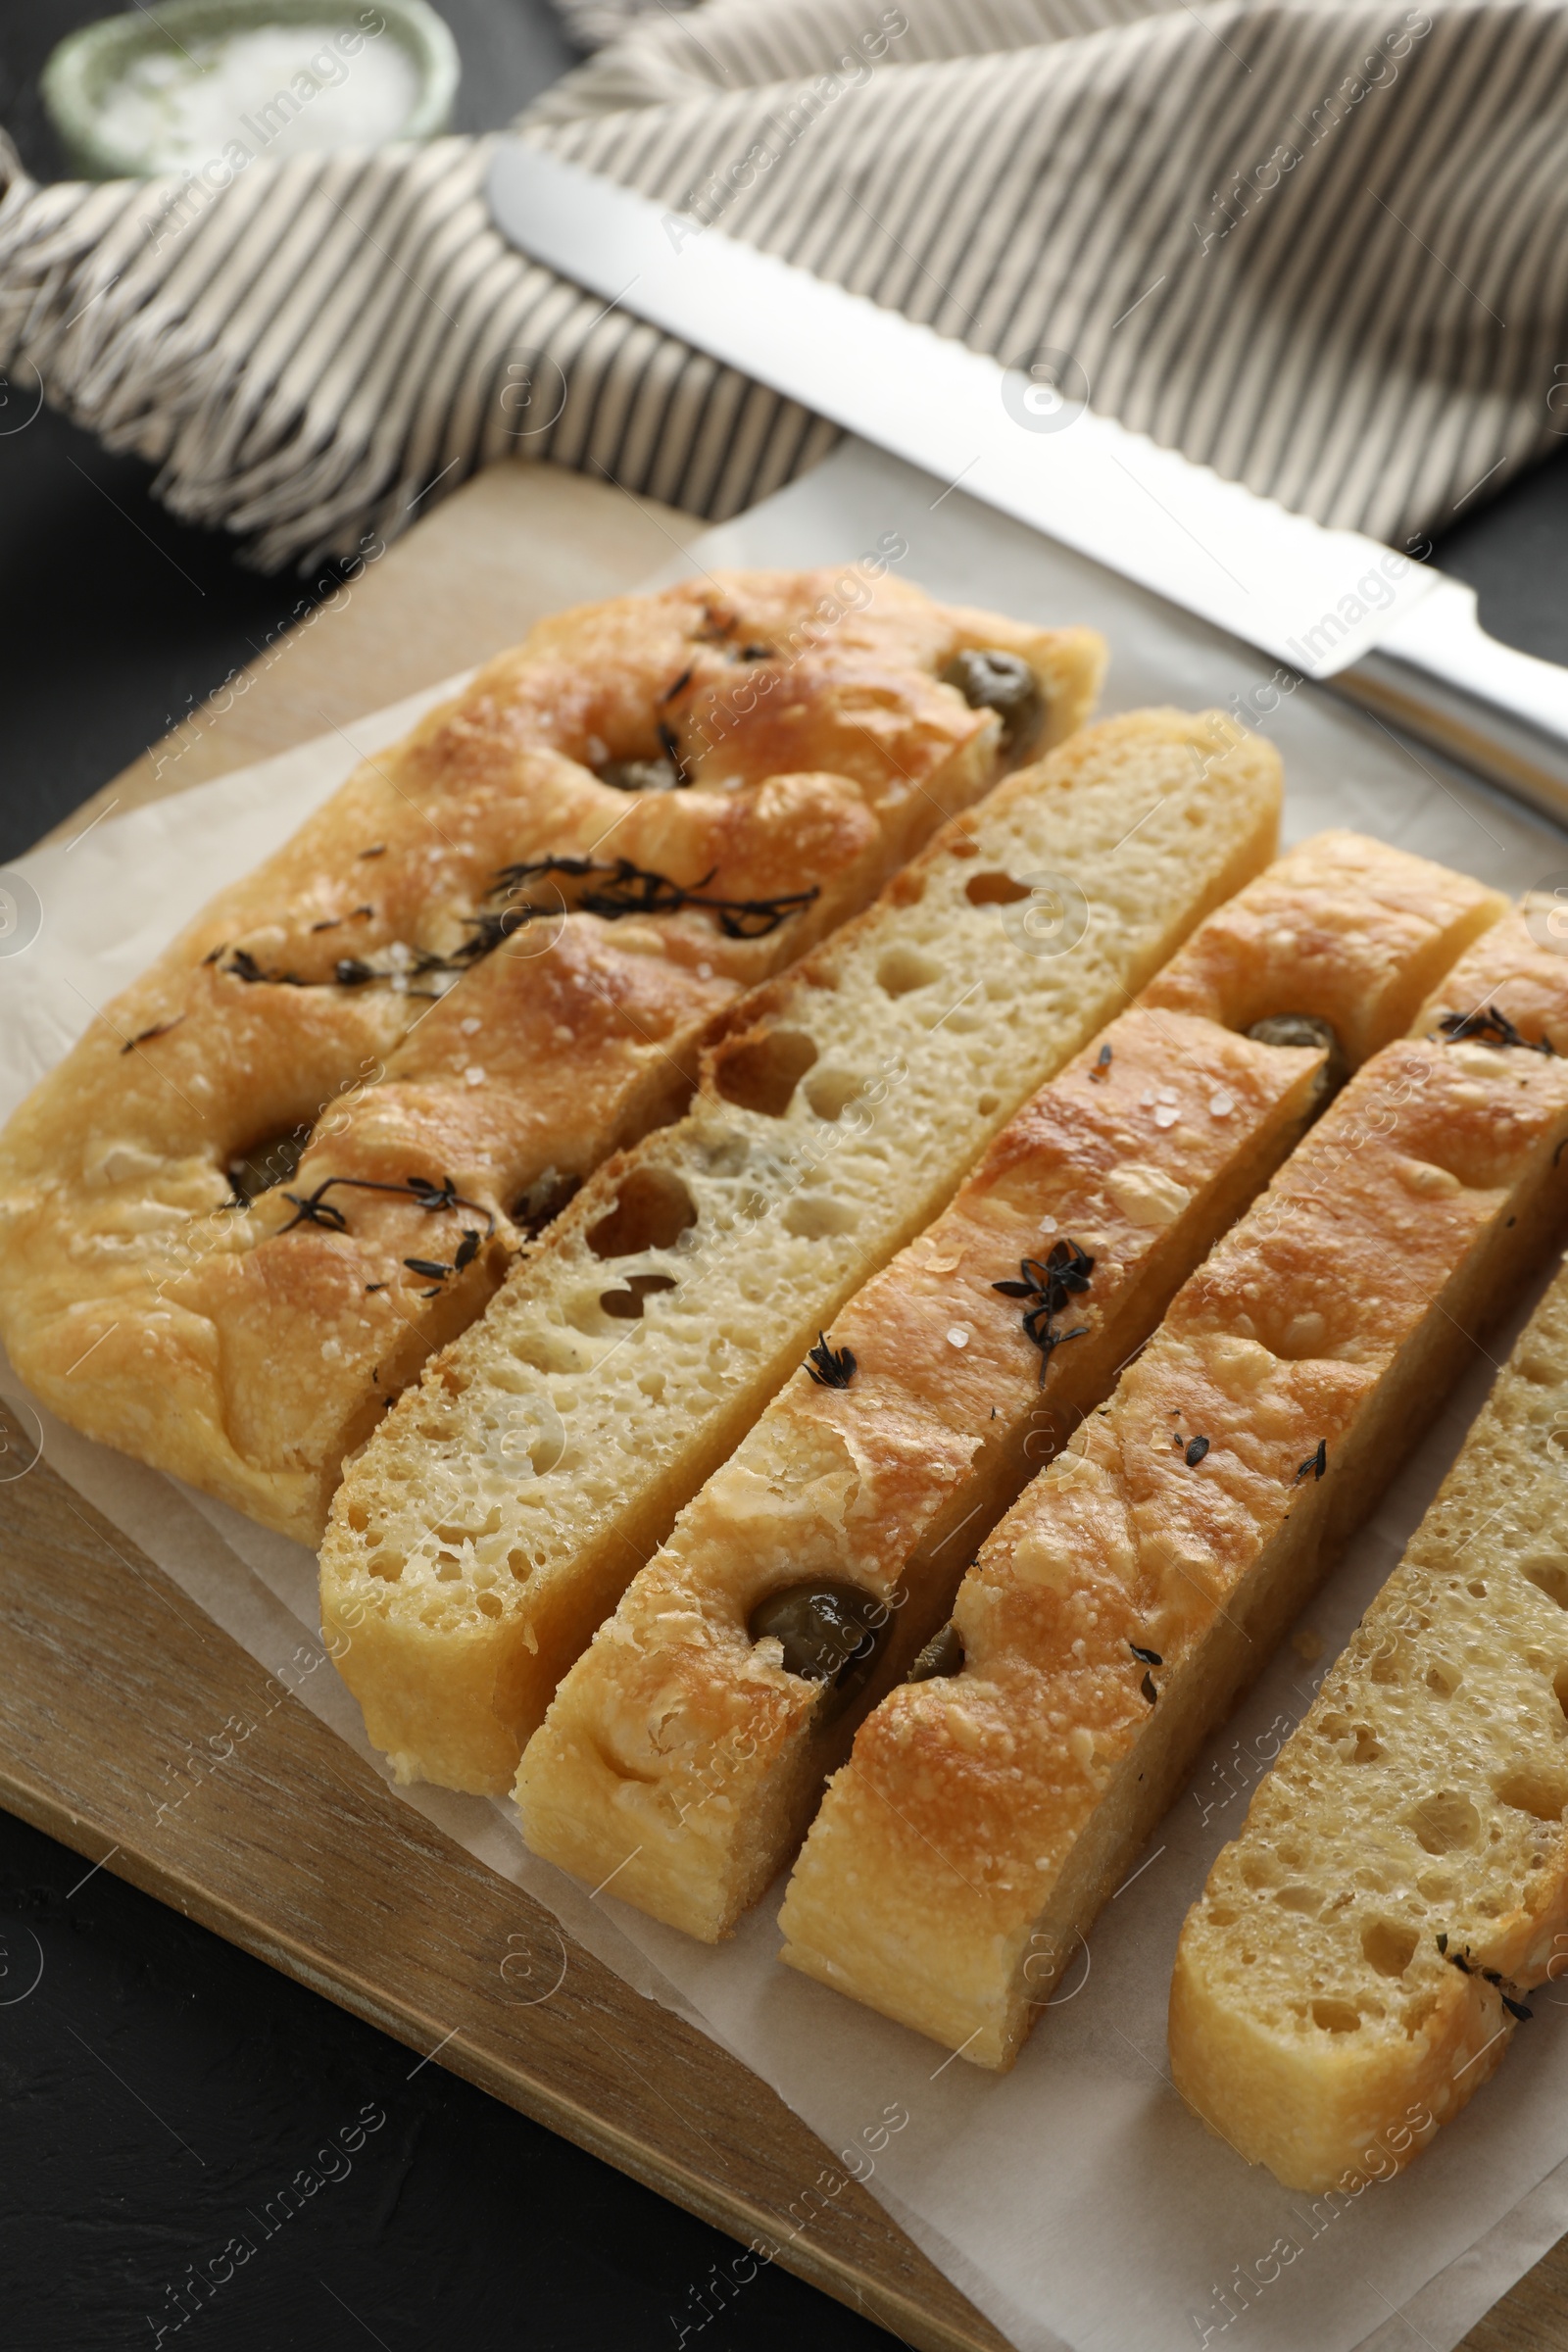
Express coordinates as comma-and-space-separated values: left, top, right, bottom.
780, 915, 1568, 2068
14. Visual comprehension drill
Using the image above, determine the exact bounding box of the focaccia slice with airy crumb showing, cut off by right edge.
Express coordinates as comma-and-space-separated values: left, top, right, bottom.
1171, 912, 1568, 2192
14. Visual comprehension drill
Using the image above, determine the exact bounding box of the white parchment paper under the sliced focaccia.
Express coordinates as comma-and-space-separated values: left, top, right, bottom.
0, 445, 1568, 2352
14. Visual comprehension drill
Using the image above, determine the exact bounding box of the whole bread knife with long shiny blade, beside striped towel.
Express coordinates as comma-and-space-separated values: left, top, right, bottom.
489, 139, 1568, 823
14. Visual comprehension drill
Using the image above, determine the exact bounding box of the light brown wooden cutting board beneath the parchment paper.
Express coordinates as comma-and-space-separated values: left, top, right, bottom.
0, 464, 1568, 2352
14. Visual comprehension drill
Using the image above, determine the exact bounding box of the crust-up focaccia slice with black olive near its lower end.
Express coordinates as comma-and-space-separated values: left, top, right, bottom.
517, 833, 1504, 1940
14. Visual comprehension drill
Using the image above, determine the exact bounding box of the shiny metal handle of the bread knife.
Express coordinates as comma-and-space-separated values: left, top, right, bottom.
1324, 576, 1568, 825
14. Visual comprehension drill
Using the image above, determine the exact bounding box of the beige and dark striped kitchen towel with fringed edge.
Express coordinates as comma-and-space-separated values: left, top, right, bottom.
0, 0, 1568, 566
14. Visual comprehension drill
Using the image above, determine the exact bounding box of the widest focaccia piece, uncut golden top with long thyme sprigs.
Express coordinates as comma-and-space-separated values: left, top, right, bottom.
0, 557, 1102, 1543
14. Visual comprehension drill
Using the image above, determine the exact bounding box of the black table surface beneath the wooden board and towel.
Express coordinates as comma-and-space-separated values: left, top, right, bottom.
0, 0, 1568, 2352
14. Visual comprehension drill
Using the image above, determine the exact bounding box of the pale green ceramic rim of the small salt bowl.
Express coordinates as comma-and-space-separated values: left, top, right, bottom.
42, 0, 459, 178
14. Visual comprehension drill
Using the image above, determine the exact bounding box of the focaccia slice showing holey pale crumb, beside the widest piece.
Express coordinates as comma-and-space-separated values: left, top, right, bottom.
322, 710, 1279, 1792
